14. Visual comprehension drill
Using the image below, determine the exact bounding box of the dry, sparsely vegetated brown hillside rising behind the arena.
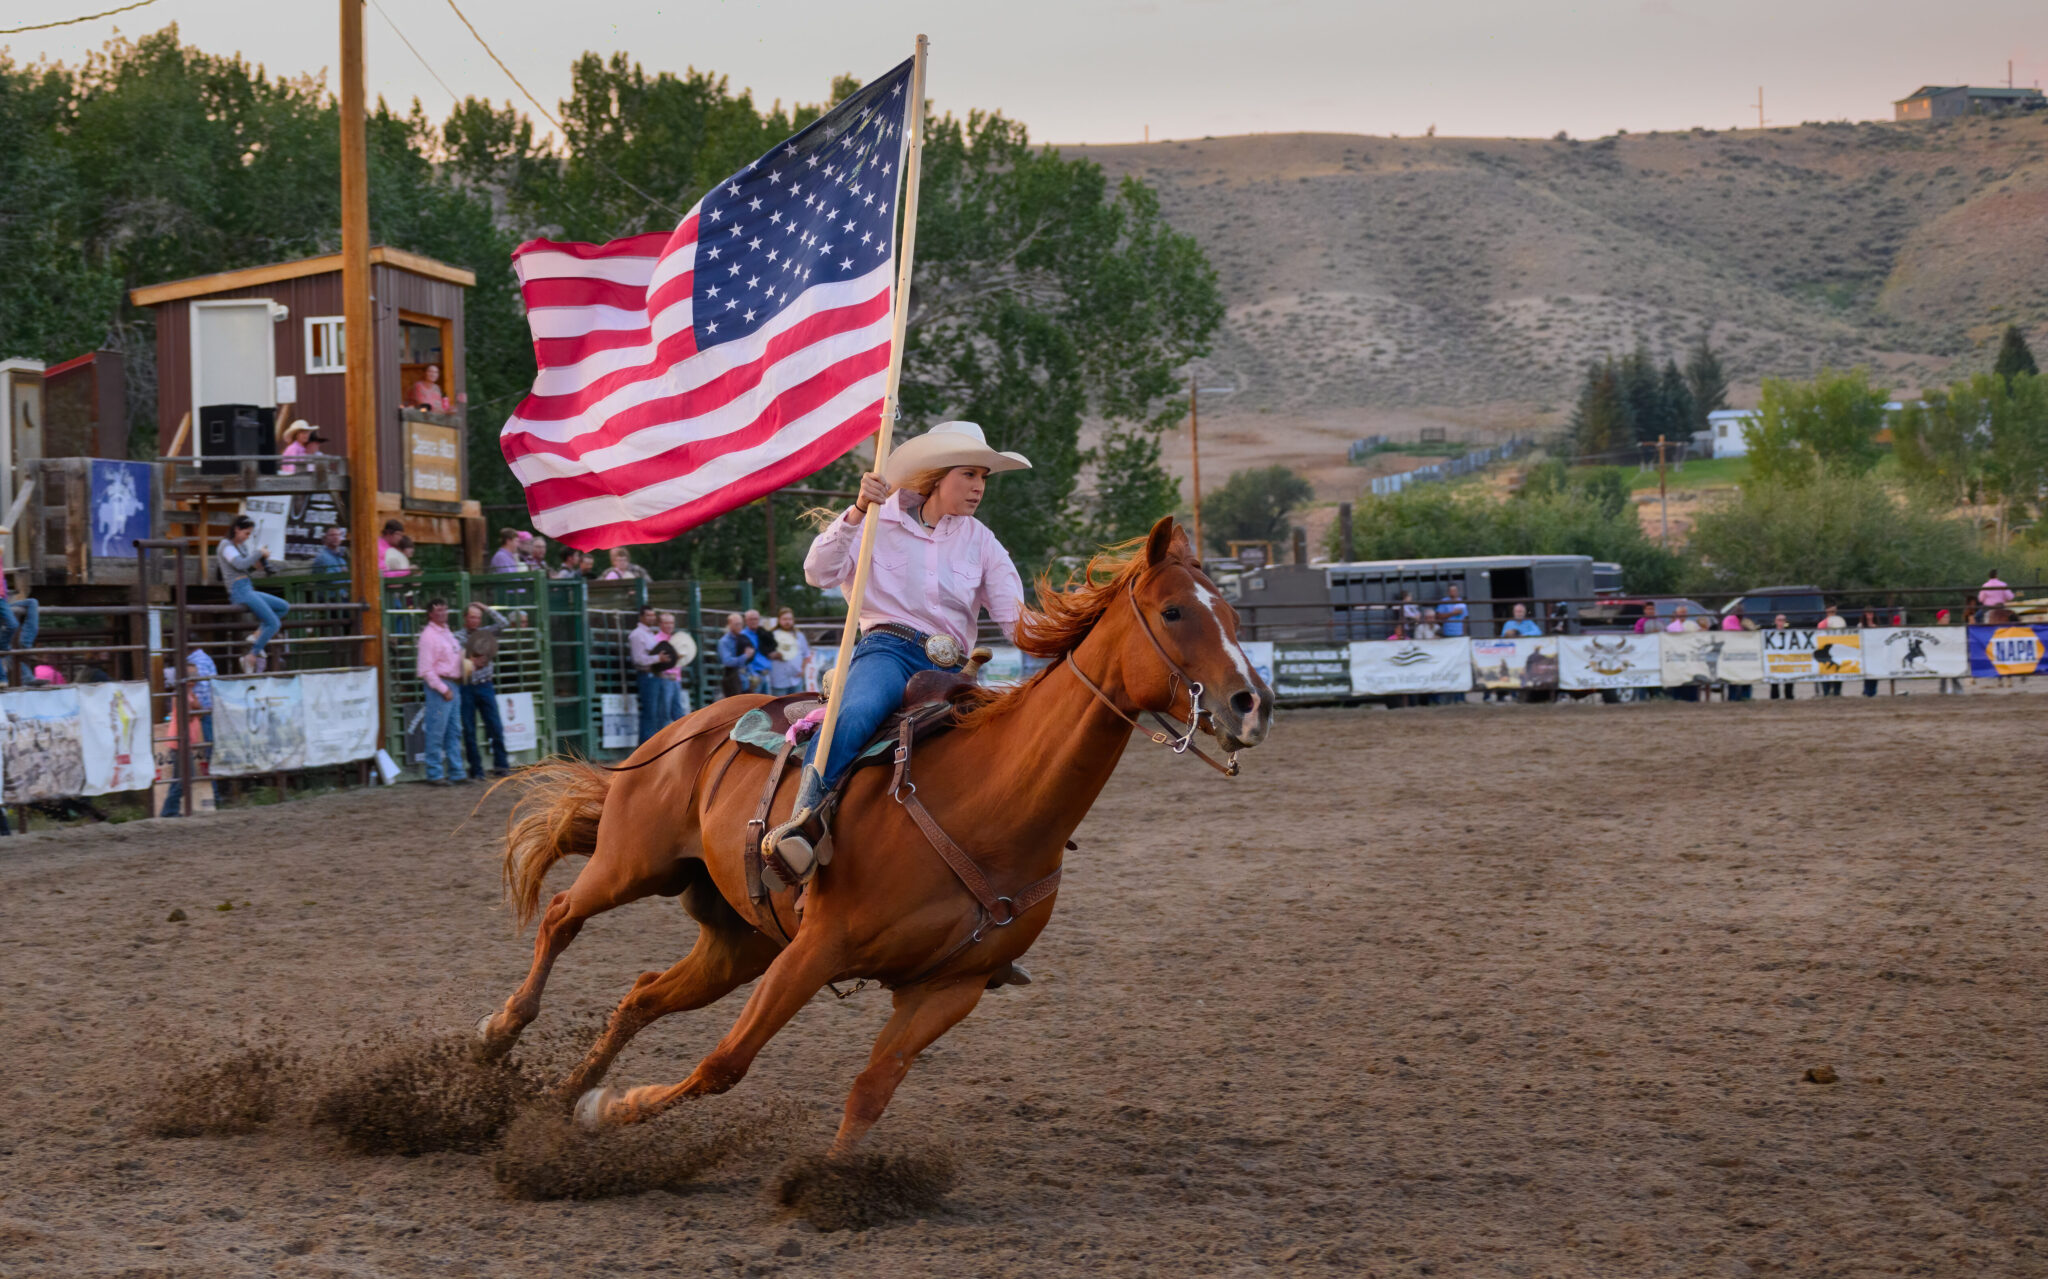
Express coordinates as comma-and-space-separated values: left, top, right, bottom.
1071, 113, 2048, 454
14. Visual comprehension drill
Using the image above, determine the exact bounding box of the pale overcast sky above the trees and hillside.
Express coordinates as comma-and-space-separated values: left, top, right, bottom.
0, 0, 2048, 143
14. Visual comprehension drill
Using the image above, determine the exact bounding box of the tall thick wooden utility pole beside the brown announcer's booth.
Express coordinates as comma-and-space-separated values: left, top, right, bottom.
340, 0, 383, 687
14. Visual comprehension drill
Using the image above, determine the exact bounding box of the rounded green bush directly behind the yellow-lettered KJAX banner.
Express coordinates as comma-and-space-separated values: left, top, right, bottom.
1688, 473, 1989, 591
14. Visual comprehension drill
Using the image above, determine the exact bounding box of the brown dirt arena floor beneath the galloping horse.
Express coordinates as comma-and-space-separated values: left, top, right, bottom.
0, 696, 2048, 1277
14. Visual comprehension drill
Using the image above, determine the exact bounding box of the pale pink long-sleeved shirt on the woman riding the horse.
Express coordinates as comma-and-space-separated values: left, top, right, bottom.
803, 491, 1024, 649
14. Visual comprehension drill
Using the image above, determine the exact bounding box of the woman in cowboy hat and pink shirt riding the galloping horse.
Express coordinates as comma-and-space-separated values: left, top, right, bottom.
762, 422, 1030, 884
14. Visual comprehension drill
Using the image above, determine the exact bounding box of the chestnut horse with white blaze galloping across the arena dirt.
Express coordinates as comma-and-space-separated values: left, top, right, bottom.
477, 520, 1272, 1154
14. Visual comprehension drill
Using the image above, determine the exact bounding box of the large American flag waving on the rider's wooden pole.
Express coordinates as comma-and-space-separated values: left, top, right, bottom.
500, 61, 911, 550
